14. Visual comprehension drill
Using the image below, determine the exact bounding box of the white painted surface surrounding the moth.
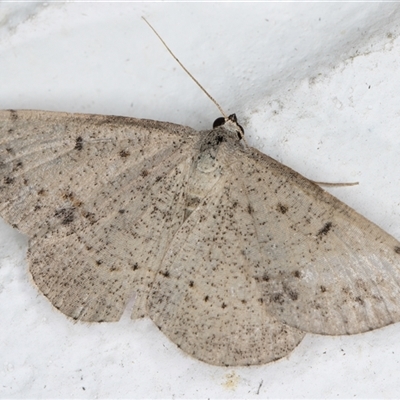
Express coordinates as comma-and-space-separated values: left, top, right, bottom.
0, 3, 400, 398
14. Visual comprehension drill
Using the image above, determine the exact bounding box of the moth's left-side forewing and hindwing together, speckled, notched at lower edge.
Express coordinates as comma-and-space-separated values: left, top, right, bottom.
0, 111, 198, 321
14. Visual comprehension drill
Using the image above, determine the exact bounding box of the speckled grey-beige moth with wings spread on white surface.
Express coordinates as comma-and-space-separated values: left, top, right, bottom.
0, 20, 400, 366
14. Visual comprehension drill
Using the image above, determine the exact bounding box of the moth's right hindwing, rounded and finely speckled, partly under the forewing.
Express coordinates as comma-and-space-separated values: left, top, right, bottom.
148, 173, 304, 366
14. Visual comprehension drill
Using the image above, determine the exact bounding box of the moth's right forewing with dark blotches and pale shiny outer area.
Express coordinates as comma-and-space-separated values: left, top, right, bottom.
241, 149, 400, 335
